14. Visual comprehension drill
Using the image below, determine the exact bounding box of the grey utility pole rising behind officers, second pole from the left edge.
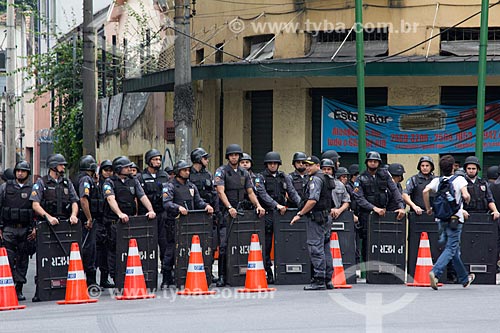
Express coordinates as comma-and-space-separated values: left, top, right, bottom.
82, 0, 97, 156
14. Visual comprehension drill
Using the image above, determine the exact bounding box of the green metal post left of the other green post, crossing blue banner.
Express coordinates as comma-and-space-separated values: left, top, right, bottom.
355, 0, 366, 172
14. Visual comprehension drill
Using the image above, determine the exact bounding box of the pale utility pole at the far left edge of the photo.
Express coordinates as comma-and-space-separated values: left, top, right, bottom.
3, 0, 16, 170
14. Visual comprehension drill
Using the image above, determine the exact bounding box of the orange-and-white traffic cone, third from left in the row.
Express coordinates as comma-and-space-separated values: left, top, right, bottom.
116, 238, 156, 300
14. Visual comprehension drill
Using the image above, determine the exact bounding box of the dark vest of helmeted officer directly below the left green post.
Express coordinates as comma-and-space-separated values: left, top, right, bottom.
358, 169, 389, 208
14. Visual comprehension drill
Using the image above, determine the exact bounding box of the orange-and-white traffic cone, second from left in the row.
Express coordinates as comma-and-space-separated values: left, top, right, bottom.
57, 243, 97, 304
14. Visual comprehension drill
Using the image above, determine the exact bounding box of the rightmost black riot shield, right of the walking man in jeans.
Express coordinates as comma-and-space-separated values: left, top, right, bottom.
460, 213, 498, 284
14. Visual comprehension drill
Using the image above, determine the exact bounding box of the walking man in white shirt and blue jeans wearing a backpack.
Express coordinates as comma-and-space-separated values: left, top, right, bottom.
423, 155, 475, 290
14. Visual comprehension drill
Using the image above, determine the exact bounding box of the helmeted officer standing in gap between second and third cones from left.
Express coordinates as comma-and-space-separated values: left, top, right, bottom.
78, 155, 100, 287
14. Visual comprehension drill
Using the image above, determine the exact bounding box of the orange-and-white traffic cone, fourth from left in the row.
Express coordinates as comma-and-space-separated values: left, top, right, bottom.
177, 235, 215, 296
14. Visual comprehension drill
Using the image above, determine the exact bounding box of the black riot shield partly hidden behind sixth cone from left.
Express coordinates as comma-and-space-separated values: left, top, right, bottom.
332, 211, 356, 284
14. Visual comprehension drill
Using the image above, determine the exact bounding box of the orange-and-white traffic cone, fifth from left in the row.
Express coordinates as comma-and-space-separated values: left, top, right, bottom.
238, 234, 276, 293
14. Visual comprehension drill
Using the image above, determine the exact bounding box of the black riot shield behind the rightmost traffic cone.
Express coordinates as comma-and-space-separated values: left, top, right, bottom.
407, 212, 447, 283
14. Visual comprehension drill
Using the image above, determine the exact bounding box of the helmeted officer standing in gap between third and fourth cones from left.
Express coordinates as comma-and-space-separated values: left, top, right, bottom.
137, 149, 169, 286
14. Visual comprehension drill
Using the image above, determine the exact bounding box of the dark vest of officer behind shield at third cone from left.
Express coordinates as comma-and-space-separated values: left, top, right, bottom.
104, 176, 137, 219
